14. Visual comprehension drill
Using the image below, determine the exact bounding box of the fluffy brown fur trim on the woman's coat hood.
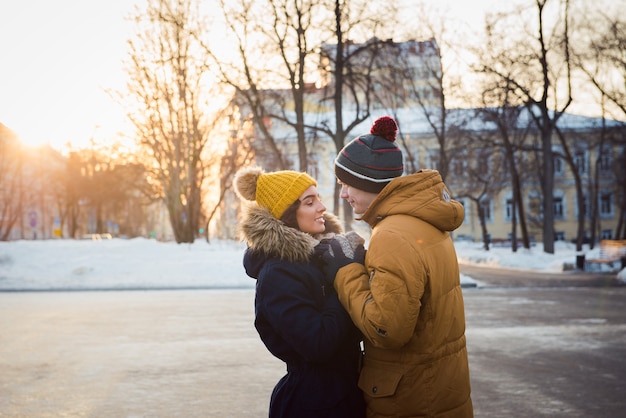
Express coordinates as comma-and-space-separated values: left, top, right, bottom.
239, 205, 343, 262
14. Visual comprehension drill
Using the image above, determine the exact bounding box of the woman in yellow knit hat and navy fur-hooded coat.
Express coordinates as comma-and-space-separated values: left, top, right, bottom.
234, 167, 365, 418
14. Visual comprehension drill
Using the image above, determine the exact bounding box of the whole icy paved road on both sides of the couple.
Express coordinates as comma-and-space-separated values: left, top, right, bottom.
0, 266, 626, 418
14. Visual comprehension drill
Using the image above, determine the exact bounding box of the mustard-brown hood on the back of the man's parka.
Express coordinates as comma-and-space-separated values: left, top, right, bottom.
360, 170, 465, 231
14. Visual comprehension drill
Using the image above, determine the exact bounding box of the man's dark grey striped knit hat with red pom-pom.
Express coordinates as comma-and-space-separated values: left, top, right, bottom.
335, 116, 404, 193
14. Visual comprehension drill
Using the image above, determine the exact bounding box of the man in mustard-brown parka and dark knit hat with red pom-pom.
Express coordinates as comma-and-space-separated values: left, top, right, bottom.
324, 116, 473, 417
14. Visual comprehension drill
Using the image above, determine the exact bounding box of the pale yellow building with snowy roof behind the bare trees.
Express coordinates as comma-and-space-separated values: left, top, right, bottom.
222, 39, 626, 243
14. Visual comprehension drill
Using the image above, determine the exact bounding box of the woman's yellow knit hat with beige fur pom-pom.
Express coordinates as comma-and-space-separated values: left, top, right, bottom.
233, 167, 317, 219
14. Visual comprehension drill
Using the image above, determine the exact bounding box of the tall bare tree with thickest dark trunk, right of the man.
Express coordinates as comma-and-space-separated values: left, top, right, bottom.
478, 0, 572, 254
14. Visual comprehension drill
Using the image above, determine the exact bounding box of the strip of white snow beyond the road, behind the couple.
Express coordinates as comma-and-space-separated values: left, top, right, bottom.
0, 238, 625, 291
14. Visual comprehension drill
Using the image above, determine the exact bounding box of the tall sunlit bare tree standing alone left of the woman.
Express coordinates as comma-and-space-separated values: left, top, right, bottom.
125, 0, 219, 243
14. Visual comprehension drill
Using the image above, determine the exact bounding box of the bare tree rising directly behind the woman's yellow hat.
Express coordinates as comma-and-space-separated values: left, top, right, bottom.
201, 0, 326, 171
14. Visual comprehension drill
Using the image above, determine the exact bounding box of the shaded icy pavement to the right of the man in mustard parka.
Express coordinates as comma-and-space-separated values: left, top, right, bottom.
461, 266, 626, 418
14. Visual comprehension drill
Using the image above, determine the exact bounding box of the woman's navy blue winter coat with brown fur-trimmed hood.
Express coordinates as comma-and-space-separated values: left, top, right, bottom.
243, 208, 365, 418
